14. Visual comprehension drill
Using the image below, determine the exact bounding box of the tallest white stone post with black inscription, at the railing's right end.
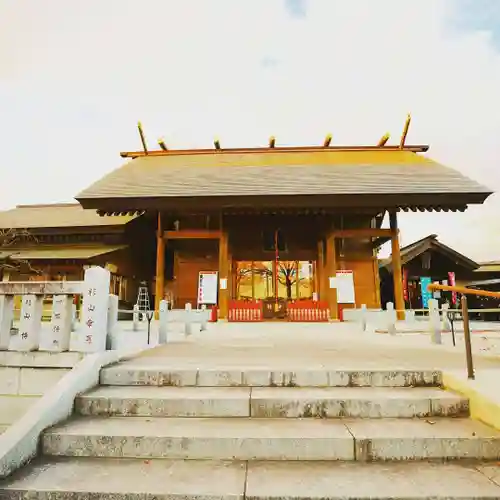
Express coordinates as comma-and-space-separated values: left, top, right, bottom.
79, 266, 110, 352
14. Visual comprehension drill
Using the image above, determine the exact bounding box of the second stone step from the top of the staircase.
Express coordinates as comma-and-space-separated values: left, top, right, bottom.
75, 386, 469, 418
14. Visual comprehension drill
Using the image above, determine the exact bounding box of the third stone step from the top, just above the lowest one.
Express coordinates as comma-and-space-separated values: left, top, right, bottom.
42, 417, 500, 461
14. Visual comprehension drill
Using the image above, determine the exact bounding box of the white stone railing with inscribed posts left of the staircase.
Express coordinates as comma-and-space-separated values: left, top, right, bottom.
0, 267, 114, 352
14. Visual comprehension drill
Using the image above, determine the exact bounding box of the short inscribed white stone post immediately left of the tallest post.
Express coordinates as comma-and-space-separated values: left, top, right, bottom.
40, 295, 73, 352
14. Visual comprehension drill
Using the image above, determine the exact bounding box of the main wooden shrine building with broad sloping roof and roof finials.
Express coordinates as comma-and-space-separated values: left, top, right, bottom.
70, 122, 491, 319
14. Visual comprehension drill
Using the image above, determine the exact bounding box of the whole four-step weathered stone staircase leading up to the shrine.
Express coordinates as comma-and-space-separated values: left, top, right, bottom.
0, 359, 500, 500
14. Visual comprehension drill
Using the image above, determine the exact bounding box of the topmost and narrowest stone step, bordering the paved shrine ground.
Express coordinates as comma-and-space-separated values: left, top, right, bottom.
100, 366, 442, 387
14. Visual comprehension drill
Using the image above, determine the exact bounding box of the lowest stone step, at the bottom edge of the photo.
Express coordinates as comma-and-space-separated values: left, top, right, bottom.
0, 458, 500, 500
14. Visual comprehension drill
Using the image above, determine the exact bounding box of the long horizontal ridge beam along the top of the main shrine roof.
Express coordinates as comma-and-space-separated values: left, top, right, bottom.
120, 143, 429, 158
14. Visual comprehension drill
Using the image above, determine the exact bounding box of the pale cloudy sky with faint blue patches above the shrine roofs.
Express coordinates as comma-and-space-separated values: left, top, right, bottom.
0, 0, 500, 261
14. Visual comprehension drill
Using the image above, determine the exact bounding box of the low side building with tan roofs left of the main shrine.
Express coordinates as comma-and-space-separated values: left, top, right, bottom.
0, 203, 137, 303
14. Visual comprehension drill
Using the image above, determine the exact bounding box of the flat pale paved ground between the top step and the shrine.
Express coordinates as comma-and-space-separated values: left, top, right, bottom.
111, 323, 500, 370
